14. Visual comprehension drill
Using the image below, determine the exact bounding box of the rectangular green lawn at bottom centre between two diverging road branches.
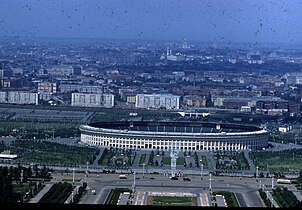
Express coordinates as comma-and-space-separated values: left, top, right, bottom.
147, 196, 197, 206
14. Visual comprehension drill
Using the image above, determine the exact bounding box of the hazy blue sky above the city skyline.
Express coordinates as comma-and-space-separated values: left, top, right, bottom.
0, 0, 302, 44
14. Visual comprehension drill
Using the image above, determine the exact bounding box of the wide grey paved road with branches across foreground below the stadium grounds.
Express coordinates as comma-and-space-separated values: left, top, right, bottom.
26, 168, 302, 207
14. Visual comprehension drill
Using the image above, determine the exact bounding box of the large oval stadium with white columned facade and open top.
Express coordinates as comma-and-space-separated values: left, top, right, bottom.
80, 121, 269, 151
